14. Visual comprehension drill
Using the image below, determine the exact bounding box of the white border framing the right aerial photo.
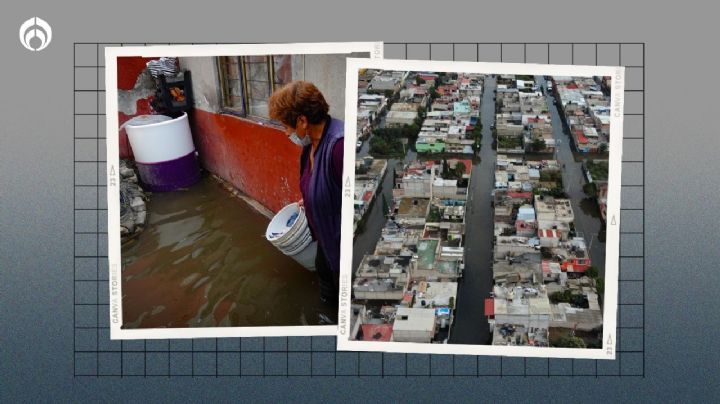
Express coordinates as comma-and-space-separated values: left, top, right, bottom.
337, 58, 625, 360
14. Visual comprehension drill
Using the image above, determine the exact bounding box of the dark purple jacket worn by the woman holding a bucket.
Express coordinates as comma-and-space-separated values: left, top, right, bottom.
300, 118, 345, 272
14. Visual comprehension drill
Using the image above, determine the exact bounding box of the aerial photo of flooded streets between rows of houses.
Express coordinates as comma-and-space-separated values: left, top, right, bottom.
348, 69, 611, 348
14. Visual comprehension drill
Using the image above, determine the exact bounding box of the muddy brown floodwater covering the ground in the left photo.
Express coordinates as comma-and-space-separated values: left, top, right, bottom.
122, 176, 337, 328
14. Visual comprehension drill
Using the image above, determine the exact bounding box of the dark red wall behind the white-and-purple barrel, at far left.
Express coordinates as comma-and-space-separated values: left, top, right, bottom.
117, 56, 158, 159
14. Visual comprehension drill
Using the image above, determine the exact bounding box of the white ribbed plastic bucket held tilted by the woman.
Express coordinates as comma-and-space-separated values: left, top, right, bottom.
265, 203, 317, 271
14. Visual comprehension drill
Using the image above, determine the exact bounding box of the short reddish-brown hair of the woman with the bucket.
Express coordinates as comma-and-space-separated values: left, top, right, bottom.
268, 80, 330, 128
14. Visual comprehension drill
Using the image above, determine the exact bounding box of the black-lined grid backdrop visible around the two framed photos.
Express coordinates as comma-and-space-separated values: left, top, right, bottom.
73, 43, 645, 377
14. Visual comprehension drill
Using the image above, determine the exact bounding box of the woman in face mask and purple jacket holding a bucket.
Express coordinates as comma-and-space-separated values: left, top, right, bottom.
269, 81, 345, 306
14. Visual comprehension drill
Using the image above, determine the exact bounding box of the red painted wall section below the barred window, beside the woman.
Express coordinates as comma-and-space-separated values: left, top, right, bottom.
190, 109, 302, 212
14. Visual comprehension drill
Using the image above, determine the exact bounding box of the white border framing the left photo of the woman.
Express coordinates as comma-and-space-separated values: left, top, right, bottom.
105, 42, 384, 340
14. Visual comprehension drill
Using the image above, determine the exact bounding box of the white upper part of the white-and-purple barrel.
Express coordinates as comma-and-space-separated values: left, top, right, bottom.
123, 112, 195, 163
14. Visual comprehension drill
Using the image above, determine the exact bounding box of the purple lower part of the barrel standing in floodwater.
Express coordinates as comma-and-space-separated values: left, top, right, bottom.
135, 151, 200, 192
